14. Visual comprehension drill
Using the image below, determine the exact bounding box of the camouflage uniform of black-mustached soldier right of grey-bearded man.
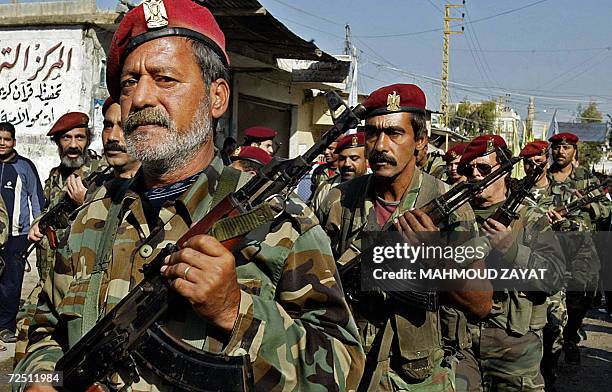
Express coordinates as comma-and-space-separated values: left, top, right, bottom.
317, 168, 477, 392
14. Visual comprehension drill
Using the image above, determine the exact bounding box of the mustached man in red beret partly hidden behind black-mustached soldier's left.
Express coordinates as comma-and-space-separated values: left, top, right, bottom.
312, 132, 368, 211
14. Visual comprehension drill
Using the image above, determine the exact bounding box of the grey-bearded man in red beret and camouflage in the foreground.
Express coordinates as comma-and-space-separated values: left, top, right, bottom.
17, 0, 364, 391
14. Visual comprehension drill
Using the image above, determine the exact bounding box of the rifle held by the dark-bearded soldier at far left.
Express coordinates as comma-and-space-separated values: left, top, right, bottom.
19, 166, 112, 264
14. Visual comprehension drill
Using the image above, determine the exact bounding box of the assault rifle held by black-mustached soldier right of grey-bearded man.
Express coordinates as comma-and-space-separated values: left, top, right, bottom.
339, 149, 521, 311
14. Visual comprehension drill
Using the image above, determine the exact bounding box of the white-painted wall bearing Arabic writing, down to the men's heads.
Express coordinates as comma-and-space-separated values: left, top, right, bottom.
0, 27, 99, 181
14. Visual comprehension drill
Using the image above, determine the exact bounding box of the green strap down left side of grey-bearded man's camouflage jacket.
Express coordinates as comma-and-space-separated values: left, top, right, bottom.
81, 179, 132, 336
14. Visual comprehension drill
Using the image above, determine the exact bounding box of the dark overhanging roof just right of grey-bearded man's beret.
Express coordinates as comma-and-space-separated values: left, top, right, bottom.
196, 0, 337, 65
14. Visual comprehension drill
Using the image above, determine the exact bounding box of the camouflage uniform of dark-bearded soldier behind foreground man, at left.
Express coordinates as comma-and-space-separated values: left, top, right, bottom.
13, 150, 106, 364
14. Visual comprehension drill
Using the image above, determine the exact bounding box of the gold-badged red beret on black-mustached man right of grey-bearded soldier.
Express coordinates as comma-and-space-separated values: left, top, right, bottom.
363, 84, 427, 118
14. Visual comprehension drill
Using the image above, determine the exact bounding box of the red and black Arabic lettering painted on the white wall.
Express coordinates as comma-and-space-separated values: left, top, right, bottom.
0, 30, 83, 134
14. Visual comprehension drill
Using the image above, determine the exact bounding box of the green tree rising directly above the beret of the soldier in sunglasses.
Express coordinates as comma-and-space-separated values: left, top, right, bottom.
450, 101, 496, 136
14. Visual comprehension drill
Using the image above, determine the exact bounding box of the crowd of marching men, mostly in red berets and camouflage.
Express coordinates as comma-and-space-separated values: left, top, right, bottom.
0, 0, 612, 392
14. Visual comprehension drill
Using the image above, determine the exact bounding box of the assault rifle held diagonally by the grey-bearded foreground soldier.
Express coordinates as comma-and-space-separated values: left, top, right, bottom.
55, 92, 365, 391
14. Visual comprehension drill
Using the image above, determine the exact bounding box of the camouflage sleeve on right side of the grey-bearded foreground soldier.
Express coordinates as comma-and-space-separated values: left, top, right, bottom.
225, 225, 364, 391
